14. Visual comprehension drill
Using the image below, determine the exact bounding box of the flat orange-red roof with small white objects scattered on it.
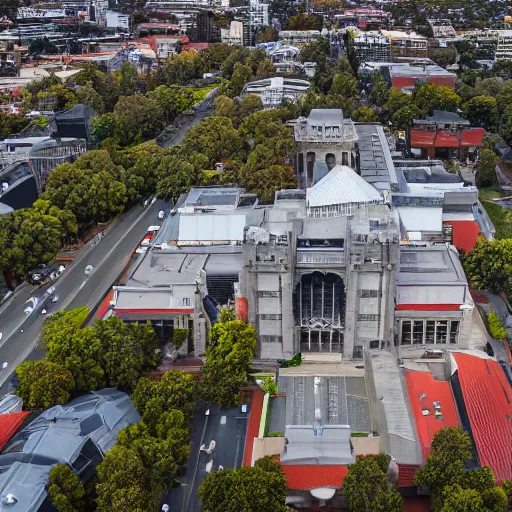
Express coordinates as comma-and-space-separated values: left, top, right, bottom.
404, 370, 459, 460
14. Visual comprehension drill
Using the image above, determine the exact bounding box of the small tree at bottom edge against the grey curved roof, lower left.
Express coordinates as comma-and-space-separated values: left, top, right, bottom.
48, 464, 85, 512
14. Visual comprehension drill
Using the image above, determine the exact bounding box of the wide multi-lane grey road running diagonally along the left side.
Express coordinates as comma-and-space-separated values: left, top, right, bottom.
0, 201, 164, 397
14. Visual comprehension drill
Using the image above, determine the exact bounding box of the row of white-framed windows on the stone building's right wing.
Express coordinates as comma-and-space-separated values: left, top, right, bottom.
400, 320, 459, 345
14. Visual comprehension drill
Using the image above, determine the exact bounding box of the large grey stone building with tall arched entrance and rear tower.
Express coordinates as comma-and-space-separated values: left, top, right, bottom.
109, 110, 485, 360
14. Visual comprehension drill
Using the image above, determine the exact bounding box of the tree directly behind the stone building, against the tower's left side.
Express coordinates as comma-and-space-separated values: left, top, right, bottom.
241, 165, 297, 203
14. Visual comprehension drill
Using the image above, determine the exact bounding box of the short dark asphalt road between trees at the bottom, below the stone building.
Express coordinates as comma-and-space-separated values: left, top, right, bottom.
167, 403, 248, 512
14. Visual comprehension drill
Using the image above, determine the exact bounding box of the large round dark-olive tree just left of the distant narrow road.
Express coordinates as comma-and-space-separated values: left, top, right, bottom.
114, 95, 165, 146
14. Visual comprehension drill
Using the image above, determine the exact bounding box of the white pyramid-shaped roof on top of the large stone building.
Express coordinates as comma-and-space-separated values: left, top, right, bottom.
306, 165, 382, 208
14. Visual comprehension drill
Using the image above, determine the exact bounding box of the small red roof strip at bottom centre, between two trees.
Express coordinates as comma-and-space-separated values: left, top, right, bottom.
281, 464, 348, 491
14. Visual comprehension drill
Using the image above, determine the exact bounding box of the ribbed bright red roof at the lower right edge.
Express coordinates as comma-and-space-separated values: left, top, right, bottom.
453, 353, 512, 482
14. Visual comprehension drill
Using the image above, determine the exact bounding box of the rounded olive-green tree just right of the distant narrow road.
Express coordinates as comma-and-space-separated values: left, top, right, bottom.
181, 116, 242, 168
